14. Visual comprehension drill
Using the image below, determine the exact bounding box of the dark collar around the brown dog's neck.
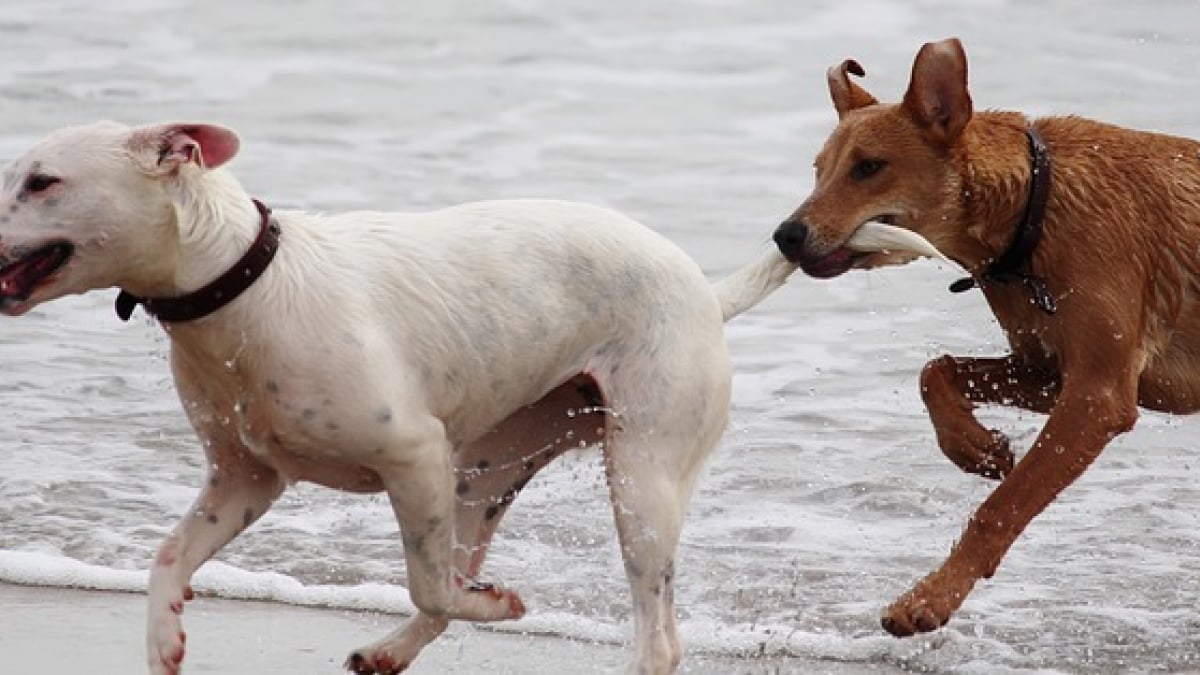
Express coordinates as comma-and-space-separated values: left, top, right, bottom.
950, 124, 1058, 313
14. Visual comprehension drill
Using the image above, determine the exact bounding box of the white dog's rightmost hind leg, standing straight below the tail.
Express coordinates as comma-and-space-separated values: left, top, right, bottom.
598, 345, 731, 675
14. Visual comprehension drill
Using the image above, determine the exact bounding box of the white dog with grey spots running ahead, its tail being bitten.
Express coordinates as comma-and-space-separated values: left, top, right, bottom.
0, 123, 794, 674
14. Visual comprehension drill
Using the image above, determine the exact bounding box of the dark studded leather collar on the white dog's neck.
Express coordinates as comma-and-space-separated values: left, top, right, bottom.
116, 199, 280, 322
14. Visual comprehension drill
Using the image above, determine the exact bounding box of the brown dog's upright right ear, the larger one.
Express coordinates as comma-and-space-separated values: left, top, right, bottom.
902, 37, 972, 145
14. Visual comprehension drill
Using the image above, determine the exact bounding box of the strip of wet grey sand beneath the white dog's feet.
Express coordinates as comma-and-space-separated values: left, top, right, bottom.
0, 584, 898, 675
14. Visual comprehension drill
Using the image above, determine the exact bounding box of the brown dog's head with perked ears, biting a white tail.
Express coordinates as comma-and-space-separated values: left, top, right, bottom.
775, 38, 972, 277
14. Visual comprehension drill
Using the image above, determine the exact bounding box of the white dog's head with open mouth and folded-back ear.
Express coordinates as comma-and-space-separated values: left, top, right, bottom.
0, 123, 238, 316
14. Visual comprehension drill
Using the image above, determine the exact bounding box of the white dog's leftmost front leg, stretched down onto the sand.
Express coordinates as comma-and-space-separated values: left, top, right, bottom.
146, 452, 283, 675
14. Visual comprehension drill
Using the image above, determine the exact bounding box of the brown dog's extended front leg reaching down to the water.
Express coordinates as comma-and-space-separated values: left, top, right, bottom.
883, 369, 1138, 637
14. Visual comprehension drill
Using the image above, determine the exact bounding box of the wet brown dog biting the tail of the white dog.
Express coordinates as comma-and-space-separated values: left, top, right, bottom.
775, 40, 1200, 635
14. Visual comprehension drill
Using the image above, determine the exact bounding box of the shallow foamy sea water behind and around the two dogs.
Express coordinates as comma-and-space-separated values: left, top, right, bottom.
0, 0, 1200, 673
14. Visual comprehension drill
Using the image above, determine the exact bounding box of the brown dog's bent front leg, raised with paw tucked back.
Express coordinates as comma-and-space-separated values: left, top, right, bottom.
920, 356, 1060, 478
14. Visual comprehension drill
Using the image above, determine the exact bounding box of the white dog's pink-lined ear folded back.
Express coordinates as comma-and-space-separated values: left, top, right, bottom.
130, 124, 241, 174
